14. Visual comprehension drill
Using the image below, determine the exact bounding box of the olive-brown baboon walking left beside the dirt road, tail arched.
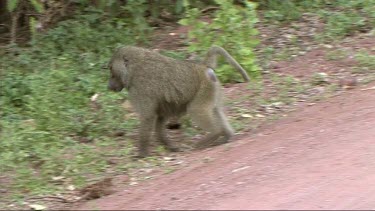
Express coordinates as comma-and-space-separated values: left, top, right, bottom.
108, 46, 249, 158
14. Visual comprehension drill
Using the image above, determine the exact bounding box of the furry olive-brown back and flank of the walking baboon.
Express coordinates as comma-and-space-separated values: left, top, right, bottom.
121, 47, 206, 103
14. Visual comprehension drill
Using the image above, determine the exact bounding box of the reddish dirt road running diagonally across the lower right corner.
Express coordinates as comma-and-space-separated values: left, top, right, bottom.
79, 83, 375, 210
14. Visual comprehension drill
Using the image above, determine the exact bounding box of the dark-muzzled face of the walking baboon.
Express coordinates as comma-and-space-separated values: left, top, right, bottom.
108, 52, 126, 92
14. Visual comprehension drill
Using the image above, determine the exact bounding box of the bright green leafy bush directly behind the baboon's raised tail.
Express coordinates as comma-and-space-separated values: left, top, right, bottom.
180, 0, 260, 82
